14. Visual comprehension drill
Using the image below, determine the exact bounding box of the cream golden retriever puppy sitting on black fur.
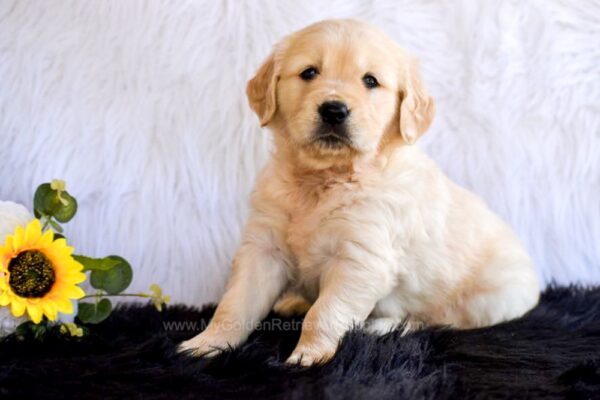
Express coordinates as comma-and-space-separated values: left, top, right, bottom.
180, 20, 539, 365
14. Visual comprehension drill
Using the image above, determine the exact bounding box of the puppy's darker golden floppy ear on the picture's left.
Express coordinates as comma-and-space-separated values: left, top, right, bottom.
246, 53, 279, 126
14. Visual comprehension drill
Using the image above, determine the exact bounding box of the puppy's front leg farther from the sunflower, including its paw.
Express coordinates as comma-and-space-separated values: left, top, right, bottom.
287, 242, 393, 366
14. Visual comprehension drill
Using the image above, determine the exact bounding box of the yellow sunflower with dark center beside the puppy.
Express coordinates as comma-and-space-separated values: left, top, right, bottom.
0, 219, 85, 324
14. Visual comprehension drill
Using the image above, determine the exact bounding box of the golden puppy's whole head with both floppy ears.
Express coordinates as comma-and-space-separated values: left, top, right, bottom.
247, 20, 435, 168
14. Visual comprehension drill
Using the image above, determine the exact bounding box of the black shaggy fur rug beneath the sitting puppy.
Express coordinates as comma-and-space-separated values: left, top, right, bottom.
0, 288, 600, 399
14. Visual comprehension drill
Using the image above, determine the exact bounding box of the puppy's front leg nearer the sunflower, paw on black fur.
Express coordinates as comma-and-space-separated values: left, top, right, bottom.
179, 223, 289, 356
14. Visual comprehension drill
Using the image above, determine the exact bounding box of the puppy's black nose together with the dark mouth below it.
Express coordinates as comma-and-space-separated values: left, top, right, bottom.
315, 101, 351, 148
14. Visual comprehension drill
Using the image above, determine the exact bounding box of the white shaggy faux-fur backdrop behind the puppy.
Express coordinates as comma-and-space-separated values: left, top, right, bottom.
0, 0, 600, 303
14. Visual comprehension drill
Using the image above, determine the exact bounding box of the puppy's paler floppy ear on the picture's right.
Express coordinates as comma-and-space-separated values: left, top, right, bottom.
400, 60, 435, 144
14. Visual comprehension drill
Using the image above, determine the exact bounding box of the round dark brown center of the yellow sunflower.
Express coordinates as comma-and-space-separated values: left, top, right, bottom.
8, 250, 55, 298
